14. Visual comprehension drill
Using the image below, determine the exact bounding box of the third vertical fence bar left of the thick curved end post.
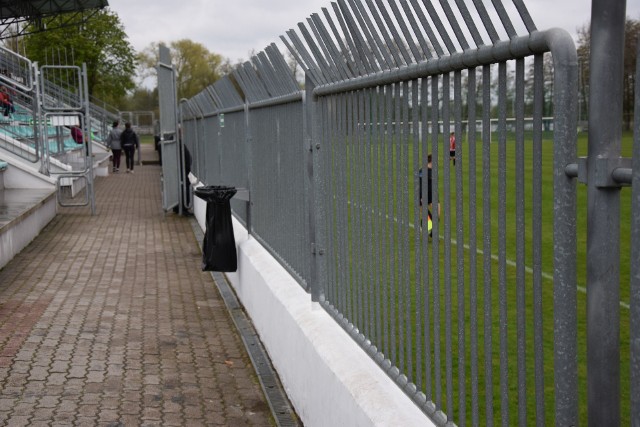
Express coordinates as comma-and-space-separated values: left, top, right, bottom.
498, 62, 509, 426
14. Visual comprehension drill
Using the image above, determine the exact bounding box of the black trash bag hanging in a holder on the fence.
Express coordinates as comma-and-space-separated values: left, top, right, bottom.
194, 185, 238, 272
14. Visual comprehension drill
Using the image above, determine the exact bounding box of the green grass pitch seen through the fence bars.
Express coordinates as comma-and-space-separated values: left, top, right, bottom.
330, 129, 632, 425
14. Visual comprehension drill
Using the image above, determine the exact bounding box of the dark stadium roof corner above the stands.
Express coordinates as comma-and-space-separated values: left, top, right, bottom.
0, 0, 109, 40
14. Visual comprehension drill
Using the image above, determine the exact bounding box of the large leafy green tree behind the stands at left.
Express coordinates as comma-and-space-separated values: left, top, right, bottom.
24, 8, 135, 104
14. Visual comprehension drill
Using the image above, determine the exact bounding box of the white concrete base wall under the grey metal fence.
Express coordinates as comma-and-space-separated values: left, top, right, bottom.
194, 198, 434, 427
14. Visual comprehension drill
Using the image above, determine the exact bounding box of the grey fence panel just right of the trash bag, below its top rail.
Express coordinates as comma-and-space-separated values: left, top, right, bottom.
249, 100, 311, 287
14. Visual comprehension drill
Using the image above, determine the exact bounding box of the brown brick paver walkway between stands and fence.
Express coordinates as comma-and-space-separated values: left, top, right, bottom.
0, 145, 274, 427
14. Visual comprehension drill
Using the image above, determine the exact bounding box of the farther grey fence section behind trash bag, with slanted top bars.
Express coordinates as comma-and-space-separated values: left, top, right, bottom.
181, 45, 310, 287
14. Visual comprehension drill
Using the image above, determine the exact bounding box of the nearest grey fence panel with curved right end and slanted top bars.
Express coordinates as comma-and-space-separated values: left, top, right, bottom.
284, 1, 577, 425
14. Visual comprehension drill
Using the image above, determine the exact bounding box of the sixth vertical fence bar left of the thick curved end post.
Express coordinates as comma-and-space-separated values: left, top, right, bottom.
453, 71, 468, 427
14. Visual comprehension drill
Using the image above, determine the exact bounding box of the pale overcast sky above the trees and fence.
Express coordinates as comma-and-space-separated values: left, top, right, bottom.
109, 0, 640, 63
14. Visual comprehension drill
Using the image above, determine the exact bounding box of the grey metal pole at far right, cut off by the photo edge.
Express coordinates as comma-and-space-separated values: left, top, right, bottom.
629, 33, 640, 427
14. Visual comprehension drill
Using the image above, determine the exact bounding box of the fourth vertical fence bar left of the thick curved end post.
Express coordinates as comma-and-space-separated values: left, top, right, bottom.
482, 65, 493, 427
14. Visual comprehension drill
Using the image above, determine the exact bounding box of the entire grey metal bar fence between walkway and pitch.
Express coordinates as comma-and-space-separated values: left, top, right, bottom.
181, 0, 640, 425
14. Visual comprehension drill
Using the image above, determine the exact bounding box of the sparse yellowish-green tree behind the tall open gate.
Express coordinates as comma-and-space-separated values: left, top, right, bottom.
138, 39, 229, 99
